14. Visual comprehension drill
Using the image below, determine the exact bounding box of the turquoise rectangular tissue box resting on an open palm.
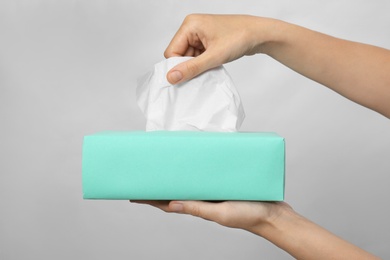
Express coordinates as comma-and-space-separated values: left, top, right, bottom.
82, 131, 285, 201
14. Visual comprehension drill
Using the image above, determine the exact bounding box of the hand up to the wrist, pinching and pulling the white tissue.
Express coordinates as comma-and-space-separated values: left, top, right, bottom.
164, 14, 276, 84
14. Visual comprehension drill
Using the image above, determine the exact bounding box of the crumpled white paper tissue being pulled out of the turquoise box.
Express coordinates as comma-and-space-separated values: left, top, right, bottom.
137, 57, 245, 132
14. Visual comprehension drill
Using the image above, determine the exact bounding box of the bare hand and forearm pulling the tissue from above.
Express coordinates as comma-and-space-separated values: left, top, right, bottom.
165, 15, 390, 118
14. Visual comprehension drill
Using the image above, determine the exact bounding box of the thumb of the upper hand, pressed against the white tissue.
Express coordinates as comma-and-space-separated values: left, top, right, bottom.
167, 51, 222, 84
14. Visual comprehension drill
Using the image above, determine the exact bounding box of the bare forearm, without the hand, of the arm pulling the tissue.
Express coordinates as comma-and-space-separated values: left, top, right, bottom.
258, 20, 390, 118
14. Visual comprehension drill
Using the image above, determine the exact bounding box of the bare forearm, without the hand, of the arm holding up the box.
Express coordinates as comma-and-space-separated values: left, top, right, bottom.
250, 207, 378, 260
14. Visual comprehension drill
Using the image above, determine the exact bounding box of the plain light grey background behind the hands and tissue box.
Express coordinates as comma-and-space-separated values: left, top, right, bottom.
0, 0, 390, 259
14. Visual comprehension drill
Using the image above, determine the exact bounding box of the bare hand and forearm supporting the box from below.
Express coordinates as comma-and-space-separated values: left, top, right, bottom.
135, 201, 378, 260
